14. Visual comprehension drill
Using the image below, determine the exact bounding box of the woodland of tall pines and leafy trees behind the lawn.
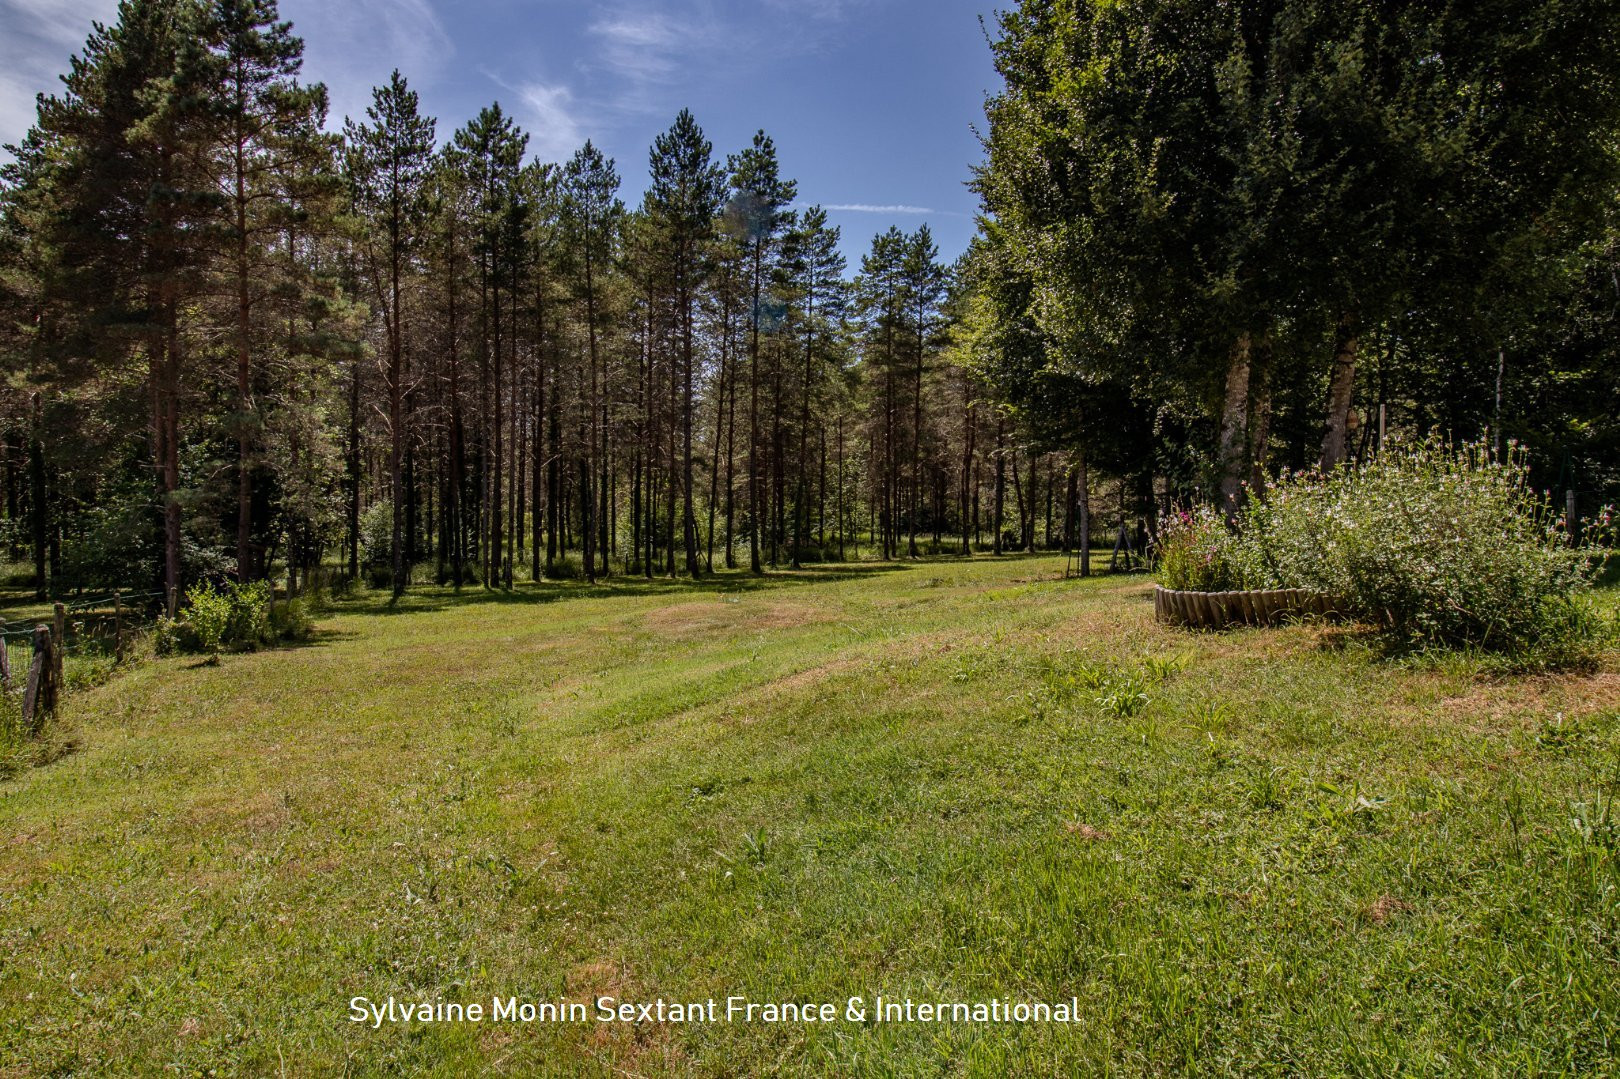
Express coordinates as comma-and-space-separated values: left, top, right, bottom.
0, 0, 1620, 614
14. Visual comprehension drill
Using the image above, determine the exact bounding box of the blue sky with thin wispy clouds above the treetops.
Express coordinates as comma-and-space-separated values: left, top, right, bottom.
0, 0, 995, 272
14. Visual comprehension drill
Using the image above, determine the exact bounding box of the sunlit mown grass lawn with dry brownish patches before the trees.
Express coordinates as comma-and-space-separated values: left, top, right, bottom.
0, 557, 1620, 1076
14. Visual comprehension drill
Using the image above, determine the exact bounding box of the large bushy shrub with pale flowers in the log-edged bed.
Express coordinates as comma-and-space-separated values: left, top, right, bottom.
1166, 439, 1614, 666
